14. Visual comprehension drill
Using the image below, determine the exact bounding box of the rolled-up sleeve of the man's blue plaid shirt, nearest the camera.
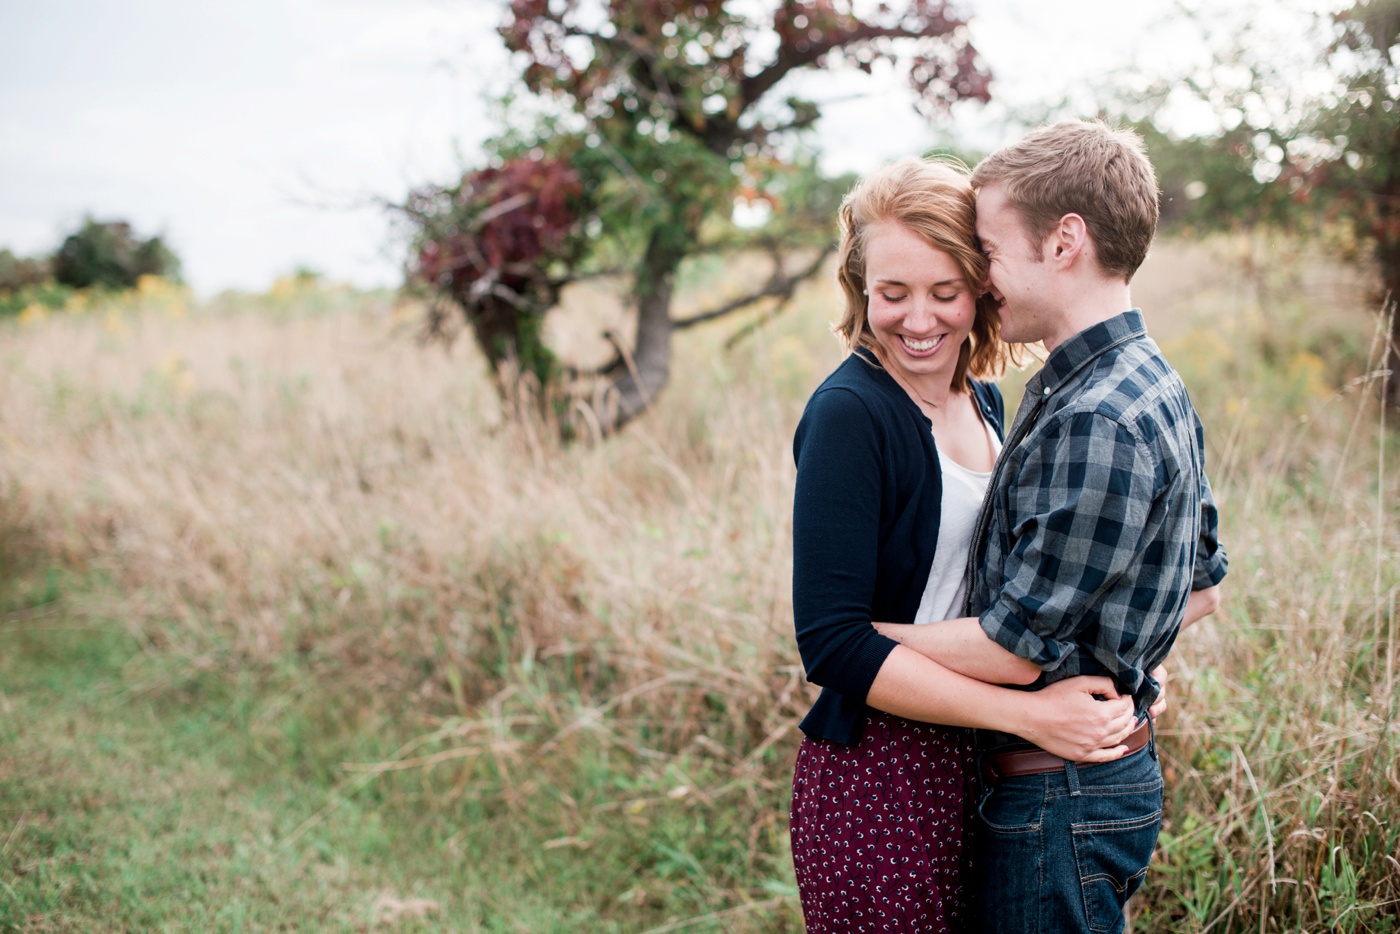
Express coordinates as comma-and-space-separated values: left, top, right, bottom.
980, 412, 1158, 671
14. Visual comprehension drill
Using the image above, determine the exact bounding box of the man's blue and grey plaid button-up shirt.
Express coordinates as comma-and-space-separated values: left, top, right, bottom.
967, 309, 1226, 711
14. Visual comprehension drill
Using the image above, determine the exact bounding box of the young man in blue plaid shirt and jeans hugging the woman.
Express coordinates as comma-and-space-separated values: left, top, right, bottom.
969, 122, 1226, 933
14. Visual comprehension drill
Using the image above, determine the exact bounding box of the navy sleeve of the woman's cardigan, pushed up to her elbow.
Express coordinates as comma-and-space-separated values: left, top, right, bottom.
792, 389, 896, 702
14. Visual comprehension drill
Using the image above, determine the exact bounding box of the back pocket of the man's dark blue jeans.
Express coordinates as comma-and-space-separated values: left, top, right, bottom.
1070, 806, 1162, 934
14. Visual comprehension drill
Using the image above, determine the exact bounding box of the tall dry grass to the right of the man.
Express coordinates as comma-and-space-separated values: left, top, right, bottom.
1131, 237, 1400, 931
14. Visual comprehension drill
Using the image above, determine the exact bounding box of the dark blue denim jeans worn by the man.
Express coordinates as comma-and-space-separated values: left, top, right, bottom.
972, 739, 1162, 934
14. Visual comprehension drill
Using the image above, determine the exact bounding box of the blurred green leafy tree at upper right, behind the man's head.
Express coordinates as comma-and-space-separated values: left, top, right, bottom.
1121, 0, 1400, 406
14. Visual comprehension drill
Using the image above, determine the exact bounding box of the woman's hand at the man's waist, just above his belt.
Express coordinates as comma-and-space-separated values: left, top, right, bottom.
1016, 675, 1137, 763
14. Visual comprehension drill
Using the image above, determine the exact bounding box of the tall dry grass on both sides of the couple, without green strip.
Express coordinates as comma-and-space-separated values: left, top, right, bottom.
0, 237, 1400, 931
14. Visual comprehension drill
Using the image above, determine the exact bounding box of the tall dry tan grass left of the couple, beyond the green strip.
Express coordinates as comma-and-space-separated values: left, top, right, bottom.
0, 274, 834, 756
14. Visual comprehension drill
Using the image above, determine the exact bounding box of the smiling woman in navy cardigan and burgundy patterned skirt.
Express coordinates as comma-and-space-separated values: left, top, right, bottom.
791, 160, 1131, 934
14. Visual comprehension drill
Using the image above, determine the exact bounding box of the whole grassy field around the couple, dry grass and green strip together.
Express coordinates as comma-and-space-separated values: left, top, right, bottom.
0, 235, 1400, 931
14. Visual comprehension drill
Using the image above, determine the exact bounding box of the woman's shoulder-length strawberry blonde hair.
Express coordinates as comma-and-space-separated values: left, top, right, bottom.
832, 158, 1015, 392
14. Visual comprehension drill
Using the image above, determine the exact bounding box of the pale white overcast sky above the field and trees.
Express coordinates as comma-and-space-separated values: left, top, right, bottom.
0, 0, 1204, 294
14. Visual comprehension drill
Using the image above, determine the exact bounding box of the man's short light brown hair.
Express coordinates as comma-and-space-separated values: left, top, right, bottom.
972, 120, 1159, 280
